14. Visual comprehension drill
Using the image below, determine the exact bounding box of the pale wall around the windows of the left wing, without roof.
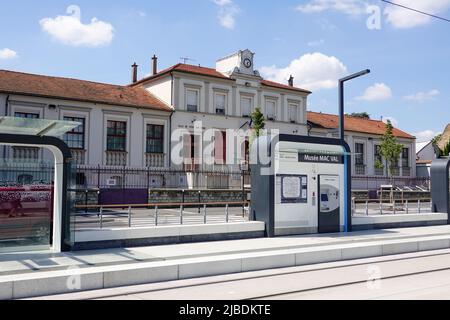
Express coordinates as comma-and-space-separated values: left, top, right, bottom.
2, 95, 170, 167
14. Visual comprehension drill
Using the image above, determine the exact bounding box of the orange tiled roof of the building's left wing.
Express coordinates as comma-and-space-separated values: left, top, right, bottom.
0, 70, 172, 111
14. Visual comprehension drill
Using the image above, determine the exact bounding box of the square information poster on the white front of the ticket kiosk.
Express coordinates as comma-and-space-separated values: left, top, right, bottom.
276, 175, 308, 203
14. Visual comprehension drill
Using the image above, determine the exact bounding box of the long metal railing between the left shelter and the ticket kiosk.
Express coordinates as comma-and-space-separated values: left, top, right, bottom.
72, 201, 252, 231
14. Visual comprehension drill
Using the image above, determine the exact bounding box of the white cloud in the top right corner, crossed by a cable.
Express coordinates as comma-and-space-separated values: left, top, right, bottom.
384, 0, 450, 29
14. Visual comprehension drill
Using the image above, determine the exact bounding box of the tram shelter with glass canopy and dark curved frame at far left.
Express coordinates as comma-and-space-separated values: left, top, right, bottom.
0, 117, 80, 252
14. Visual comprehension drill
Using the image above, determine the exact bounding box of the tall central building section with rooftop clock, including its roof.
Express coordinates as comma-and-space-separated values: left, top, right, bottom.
132, 50, 311, 170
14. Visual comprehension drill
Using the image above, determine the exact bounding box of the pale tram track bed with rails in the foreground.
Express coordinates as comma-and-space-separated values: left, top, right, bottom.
37, 250, 450, 300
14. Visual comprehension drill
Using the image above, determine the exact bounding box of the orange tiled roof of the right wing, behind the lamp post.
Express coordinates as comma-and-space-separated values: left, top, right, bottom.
308, 111, 415, 139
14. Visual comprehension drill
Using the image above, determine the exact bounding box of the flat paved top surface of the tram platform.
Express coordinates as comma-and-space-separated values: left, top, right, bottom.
0, 225, 450, 276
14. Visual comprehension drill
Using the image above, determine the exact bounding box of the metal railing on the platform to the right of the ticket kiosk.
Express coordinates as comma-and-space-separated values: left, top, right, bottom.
352, 198, 433, 216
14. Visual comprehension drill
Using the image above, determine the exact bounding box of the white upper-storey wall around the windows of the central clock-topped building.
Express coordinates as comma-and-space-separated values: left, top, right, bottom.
145, 72, 307, 169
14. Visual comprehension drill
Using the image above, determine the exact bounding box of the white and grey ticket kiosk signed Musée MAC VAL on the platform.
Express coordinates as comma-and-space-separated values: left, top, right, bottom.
251, 135, 351, 236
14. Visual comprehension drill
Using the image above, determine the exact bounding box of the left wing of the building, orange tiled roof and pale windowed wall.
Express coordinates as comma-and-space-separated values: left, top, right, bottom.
0, 71, 172, 188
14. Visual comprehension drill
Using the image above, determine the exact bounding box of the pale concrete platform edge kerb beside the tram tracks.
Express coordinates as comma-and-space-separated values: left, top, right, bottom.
4, 235, 450, 299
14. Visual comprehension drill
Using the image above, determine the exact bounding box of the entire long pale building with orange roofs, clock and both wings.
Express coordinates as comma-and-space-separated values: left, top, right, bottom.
0, 50, 416, 188
